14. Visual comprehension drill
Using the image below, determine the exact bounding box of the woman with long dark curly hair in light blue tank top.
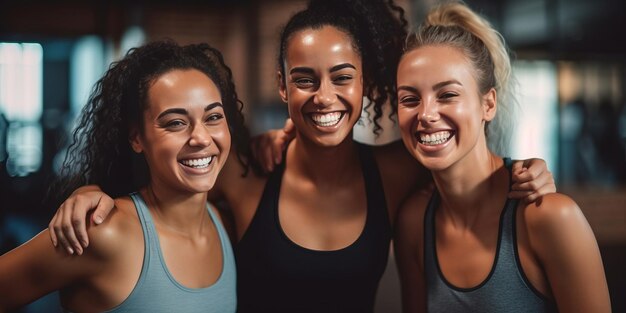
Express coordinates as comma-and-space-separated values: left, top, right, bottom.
0, 41, 241, 312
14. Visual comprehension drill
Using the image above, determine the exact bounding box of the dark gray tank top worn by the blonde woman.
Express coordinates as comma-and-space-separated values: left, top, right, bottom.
424, 159, 557, 313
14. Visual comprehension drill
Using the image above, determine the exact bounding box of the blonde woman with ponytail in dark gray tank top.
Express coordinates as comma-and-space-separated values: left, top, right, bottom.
395, 3, 611, 312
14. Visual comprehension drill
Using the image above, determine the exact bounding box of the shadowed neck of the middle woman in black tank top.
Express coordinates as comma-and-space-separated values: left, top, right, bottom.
287, 134, 360, 185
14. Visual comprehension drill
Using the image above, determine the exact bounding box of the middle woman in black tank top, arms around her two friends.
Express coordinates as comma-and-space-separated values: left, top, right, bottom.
51, 0, 554, 312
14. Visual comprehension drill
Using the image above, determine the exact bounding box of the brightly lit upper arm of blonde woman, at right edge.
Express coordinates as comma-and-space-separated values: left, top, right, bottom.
525, 194, 611, 312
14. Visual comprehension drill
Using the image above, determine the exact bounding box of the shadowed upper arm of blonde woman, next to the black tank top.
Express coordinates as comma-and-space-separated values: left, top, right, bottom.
393, 191, 428, 312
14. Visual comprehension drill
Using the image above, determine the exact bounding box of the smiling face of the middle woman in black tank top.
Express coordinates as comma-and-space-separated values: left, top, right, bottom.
279, 26, 363, 146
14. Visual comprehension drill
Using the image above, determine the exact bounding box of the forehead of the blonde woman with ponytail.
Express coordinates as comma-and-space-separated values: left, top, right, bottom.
398, 45, 474, 85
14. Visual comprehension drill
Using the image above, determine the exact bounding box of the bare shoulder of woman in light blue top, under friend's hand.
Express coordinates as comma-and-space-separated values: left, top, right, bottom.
85, 197, 143, 258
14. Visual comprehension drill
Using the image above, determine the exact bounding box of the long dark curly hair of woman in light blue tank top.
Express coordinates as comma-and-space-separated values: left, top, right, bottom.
61, 40, 250, 197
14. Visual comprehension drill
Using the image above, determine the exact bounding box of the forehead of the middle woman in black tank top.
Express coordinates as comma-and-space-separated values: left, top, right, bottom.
285, 26, 361, 67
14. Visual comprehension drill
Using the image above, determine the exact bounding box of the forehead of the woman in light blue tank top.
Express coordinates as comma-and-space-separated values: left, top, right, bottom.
148, 69, 222, 108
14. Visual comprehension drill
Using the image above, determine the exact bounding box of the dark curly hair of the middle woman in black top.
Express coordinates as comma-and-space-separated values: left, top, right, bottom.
278, 0, 408, 135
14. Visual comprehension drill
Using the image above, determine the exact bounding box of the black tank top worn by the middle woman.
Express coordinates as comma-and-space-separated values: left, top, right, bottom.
235, 144, 391, 312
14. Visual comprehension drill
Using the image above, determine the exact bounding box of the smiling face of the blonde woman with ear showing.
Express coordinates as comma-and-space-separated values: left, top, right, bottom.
397, 46, 496, 171
